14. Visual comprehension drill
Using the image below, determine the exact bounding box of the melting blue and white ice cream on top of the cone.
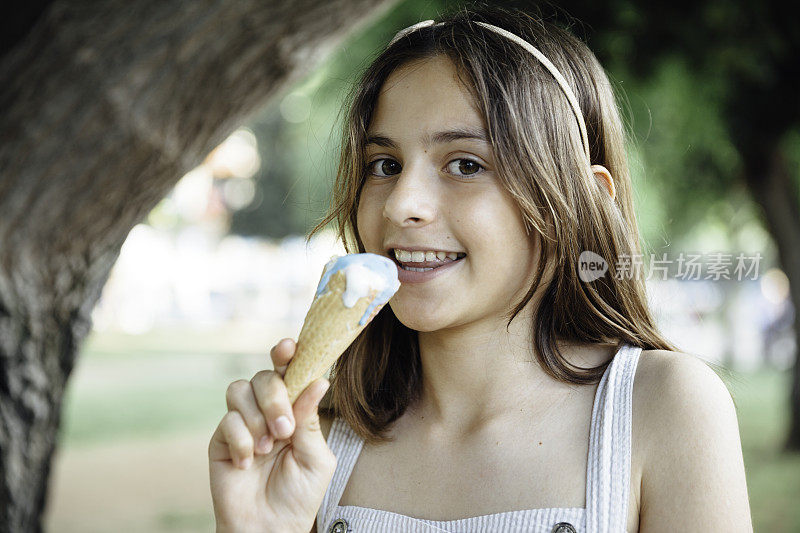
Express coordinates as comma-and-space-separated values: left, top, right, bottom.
316, 253, 400, 326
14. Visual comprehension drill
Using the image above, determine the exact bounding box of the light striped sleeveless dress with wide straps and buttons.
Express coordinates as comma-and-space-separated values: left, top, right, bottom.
317, 344, 642, 533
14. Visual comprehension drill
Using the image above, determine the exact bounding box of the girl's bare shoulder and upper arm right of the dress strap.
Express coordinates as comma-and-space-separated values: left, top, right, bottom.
633, 350, 752, 532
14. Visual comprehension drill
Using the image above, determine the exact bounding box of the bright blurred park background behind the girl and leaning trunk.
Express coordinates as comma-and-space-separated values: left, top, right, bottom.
18, 0, 800, 533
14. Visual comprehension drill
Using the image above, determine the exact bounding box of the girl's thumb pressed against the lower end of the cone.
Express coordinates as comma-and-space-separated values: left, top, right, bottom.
292, 378, 331, 468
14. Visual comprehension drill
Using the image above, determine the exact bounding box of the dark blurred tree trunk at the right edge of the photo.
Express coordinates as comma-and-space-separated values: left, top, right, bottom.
742, 142, 800, 451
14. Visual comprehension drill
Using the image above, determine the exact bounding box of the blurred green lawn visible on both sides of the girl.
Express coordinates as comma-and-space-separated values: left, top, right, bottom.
60, 330, 800, 533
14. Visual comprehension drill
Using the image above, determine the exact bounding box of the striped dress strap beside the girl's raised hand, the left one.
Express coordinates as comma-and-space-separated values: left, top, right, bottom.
317, 417, 364, 532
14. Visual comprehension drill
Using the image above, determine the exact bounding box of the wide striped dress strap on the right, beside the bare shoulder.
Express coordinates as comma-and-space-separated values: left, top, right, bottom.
586, 343, 642, 533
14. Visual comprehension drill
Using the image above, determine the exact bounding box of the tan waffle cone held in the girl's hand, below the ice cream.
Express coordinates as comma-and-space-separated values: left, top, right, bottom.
283, 270, 380, 403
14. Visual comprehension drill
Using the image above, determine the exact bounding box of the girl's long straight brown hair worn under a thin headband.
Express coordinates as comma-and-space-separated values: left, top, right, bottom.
309, 6, 675, 443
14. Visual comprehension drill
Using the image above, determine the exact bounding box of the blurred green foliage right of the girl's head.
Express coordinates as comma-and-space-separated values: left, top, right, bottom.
626, 57, 750, 251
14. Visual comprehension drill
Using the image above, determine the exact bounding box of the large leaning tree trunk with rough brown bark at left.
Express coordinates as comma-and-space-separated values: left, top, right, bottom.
0, 0, 394, 532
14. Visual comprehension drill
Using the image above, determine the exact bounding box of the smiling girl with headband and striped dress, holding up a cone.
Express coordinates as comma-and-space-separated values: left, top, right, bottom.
209, 8, 752, 533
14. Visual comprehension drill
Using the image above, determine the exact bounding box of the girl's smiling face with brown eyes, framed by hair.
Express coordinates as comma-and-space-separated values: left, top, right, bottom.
358, 56, 538, 331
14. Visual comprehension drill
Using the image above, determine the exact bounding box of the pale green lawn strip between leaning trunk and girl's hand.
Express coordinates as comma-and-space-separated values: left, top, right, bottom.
60, 324, 279, 447
